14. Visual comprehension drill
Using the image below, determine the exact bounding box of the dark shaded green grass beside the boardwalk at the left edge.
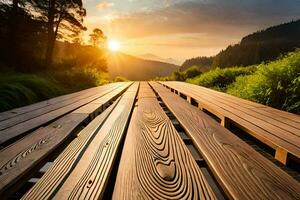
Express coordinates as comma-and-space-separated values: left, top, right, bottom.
0, 73, 65, 111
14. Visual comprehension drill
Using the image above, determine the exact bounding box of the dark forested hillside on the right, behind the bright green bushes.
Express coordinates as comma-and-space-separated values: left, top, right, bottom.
181, 20, 300, 70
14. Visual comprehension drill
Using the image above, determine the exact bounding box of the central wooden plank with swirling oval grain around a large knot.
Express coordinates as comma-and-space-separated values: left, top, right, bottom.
112, 85, 216, 199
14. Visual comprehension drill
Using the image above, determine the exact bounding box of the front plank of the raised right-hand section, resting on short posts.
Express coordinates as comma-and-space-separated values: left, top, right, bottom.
162, 82, 300, 162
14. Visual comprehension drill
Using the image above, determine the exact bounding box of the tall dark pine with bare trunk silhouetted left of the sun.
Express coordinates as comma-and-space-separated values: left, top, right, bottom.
30, 0, 86, 65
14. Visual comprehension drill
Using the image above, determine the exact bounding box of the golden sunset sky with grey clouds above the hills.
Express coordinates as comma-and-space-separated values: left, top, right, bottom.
83, 0, 300, 61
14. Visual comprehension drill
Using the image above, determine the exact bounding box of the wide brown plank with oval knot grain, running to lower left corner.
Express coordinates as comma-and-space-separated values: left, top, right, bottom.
0, 82, 127, 193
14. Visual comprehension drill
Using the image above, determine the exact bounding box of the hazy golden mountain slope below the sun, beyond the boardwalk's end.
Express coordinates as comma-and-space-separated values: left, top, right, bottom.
107, 53, 179, 81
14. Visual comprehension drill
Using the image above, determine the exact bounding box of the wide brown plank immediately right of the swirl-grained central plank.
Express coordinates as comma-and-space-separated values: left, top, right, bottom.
151, 82, 300, 199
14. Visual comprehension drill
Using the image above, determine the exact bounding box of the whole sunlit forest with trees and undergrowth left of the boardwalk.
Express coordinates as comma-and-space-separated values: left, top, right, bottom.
0, 0, 108, 111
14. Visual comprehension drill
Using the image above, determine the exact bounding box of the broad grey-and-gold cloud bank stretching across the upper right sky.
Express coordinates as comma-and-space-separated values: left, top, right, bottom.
105, 0, 300, 37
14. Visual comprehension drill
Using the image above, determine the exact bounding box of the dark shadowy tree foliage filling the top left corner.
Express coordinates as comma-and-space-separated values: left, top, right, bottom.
0, 0, 46, 71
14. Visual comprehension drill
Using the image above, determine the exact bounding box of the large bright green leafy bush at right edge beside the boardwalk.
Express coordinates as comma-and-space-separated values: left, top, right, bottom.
227, 51, 300, 114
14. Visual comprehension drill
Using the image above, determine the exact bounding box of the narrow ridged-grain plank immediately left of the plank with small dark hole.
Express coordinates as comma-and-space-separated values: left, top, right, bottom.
22, 95, 119, 200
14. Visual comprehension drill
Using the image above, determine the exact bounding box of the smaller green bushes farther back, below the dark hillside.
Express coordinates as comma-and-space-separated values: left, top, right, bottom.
187, 66, 256, 91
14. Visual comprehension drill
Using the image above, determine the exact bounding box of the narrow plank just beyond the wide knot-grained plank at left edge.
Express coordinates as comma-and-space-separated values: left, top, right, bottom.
0, 83, 129, 145
